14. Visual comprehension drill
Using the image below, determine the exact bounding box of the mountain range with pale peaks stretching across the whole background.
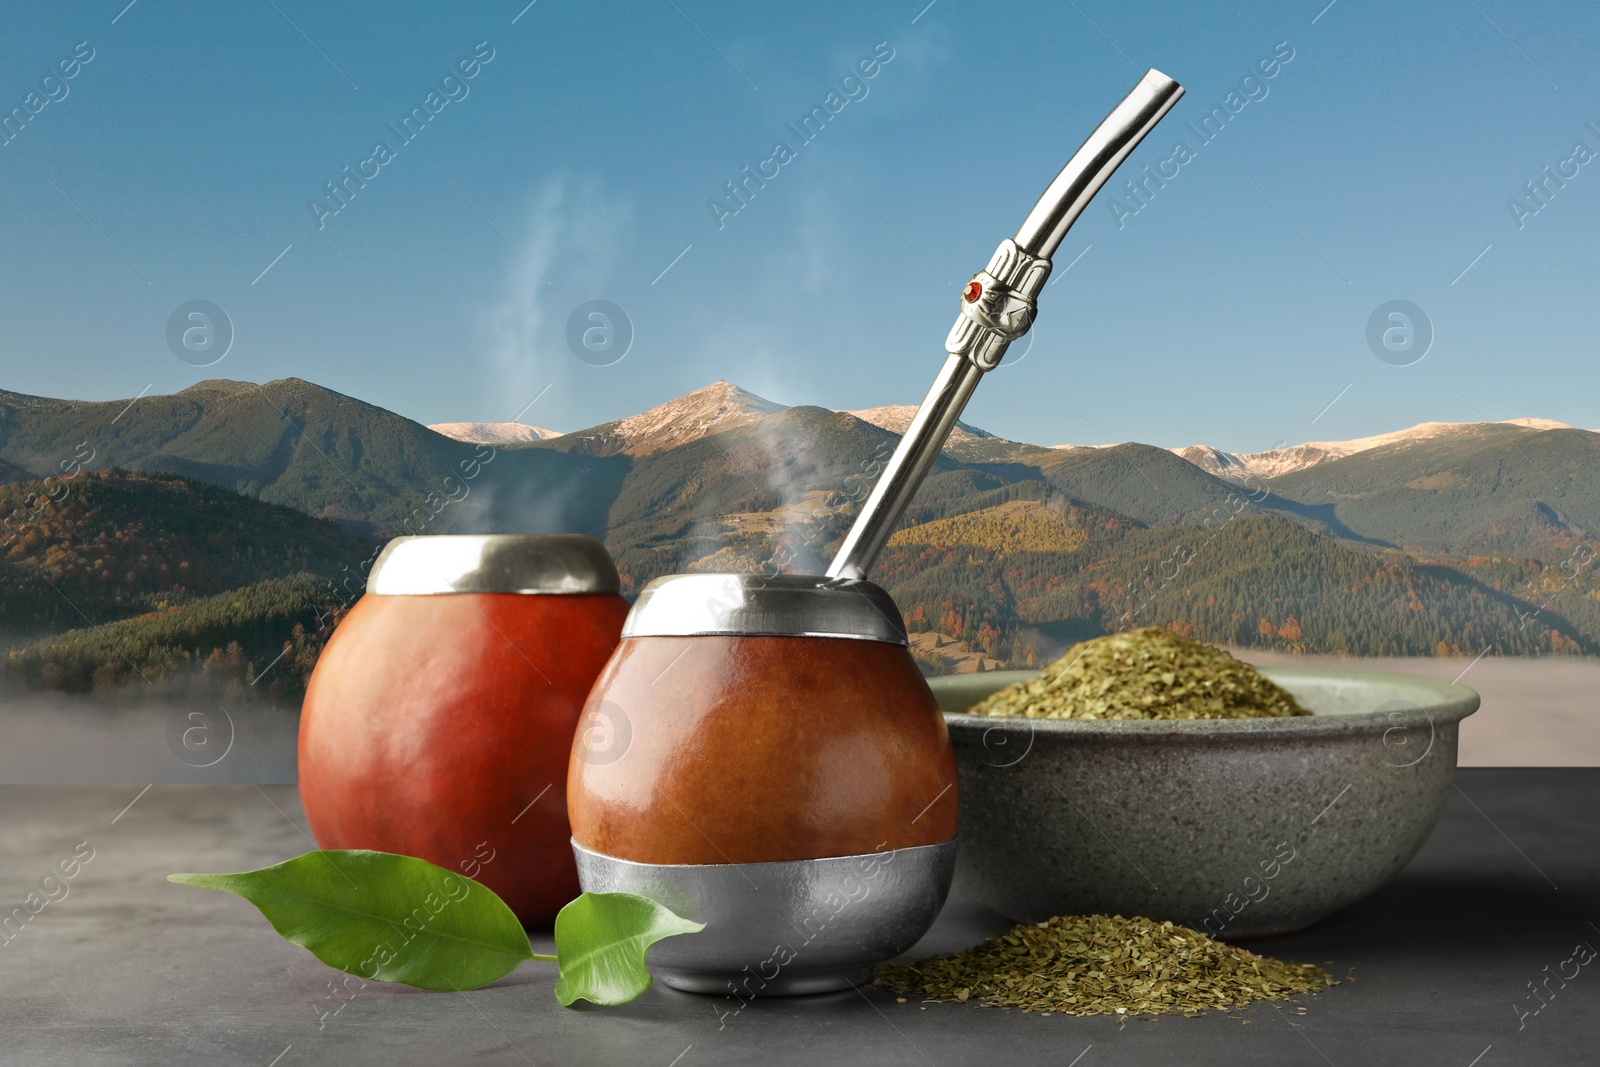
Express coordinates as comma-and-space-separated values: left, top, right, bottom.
0, 379, 1600, 694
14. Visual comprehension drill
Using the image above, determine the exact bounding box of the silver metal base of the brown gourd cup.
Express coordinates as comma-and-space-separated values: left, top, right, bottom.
573, 840, 955, 1001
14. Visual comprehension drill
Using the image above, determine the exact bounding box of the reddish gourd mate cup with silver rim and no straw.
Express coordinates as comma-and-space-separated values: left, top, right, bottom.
299, 534, 627, 926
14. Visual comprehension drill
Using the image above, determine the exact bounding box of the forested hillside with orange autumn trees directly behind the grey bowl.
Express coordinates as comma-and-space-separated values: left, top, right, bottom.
875, 509, 1580, 665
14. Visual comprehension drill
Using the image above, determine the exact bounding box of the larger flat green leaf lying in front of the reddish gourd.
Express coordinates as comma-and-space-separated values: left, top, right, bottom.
168, 849, 534, 990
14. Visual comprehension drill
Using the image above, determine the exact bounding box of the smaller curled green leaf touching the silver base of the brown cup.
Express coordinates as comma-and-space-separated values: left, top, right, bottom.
555, 893, 706, 1008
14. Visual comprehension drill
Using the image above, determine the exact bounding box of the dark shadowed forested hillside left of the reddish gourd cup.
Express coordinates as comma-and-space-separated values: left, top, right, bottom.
0, 470, 376, 702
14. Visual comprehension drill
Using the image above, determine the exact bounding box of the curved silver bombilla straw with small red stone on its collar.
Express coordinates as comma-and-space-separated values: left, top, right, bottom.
827, 70, 1184, 577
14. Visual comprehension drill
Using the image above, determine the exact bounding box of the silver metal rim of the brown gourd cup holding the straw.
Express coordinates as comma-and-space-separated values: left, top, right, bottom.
622, 574, 909, 645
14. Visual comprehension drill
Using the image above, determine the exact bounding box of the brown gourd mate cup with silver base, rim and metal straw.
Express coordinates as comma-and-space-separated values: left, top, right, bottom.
566, 70, 1182, 1003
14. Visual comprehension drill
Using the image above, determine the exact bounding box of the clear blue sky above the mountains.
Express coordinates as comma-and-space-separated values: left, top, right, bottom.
0, 0, 1600, 450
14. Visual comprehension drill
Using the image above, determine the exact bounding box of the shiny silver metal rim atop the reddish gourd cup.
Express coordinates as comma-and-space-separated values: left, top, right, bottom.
366, 534, 622, 597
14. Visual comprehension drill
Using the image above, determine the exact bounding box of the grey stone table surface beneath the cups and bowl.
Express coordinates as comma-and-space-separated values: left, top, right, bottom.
0, 769, 1600, 1067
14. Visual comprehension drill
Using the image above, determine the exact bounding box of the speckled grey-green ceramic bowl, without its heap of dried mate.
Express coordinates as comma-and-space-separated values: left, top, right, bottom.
931, 667, 1478, 937
